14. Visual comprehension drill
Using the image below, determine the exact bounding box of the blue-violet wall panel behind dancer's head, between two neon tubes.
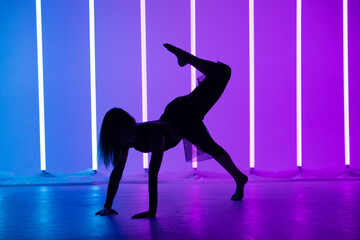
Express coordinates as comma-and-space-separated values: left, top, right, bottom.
95, 0, 142, 174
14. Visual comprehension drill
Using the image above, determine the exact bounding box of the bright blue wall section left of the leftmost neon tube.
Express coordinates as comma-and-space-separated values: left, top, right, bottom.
0, 0, 40, 175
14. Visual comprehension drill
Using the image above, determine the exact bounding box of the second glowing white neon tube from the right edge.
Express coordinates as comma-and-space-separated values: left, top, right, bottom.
296, 0, 302, 167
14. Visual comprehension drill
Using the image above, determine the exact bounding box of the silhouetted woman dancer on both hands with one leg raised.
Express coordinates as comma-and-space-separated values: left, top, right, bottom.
96, 44, 248, 219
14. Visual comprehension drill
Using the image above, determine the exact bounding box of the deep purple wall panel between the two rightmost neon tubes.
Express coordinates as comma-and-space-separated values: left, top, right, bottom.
302, 0, 345, 168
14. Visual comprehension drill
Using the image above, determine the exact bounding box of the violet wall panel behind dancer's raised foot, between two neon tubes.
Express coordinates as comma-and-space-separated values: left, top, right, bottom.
146, 0, 191, 172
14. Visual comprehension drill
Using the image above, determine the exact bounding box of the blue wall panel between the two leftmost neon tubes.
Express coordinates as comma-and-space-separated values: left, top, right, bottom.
42, 0, 91, 172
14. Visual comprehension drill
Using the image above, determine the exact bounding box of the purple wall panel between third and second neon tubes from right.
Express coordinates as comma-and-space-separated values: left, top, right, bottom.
254, 0, 296, 171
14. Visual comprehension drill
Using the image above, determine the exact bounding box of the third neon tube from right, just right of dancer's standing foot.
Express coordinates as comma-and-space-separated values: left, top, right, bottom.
249, 0, 255, 168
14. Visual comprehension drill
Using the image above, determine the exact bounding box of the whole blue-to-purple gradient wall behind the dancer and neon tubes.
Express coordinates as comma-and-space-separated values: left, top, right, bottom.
0, 0, 360, 175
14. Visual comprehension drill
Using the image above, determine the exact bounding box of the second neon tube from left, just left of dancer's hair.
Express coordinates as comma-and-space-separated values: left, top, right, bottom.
89, 0, 98, 170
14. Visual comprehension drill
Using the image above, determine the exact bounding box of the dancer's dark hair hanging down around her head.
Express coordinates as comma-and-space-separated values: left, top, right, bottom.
99, 108, 136, 168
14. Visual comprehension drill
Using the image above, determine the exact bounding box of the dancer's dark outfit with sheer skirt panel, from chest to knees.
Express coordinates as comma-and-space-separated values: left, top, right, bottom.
133, 63, 231, 161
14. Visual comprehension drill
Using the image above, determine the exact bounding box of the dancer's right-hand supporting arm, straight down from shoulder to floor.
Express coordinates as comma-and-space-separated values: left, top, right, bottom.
132, 132, 165, 218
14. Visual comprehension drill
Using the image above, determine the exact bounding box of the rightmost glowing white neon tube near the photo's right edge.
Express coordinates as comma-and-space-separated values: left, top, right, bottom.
343, 0, 350, 166
